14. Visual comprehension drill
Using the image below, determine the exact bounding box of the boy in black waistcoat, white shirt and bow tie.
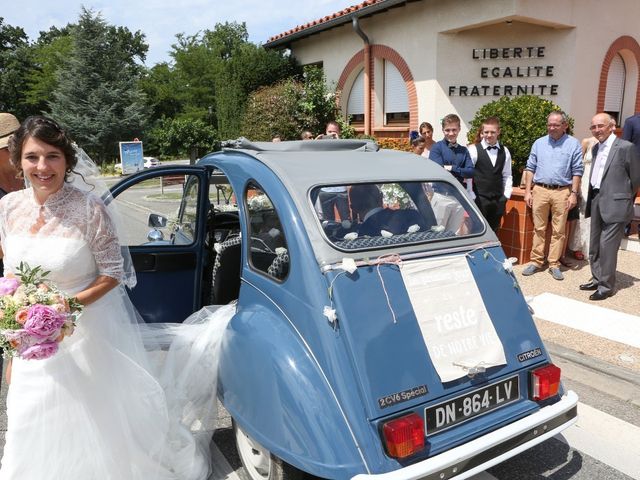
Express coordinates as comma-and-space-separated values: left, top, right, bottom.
468, 117, 513, 232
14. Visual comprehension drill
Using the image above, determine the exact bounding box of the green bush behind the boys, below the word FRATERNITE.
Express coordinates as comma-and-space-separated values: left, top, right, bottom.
467, 95, 574, 185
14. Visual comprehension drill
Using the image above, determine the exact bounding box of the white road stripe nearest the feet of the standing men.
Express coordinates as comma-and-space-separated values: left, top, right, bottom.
529, 293, 640, 348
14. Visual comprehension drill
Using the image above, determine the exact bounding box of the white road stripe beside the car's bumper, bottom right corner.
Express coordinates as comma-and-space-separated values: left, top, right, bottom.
558, 403, 640, 478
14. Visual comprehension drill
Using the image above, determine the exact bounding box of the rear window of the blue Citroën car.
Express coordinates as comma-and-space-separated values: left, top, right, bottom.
311, 182, 485, 250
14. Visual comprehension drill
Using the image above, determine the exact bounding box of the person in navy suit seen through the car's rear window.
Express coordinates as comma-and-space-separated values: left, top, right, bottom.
349, 185, 426, 237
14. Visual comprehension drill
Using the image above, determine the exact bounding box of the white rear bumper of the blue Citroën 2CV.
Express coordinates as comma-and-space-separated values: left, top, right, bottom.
352, 390, 578, 480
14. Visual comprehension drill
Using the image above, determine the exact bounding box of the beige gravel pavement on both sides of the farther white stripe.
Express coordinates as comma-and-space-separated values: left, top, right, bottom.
514, 250, 640, 372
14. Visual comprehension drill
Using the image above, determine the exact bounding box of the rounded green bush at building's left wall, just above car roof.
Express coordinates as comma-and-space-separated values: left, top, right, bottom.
242, 67, 340, 140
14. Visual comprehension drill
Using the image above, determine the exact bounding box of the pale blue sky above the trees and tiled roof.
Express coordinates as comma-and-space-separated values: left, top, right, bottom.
0, 0, 359, 66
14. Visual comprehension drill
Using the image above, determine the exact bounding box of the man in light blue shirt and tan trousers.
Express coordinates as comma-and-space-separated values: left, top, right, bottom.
522, 112, 584, 280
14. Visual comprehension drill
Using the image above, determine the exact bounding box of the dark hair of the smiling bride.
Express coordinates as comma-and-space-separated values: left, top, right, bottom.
9, 115, 78, 176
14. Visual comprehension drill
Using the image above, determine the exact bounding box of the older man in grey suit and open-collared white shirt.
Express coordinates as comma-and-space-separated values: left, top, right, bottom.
580, 113, 640, 300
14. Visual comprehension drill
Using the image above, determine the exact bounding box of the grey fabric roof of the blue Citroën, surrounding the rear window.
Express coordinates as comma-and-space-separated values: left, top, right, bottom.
205, 139, 496, 265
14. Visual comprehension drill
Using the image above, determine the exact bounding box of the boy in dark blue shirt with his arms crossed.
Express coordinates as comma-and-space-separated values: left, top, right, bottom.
429, 113, 473, 186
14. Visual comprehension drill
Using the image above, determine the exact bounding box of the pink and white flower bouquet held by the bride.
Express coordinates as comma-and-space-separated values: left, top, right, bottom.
0, 262, 82, 360
